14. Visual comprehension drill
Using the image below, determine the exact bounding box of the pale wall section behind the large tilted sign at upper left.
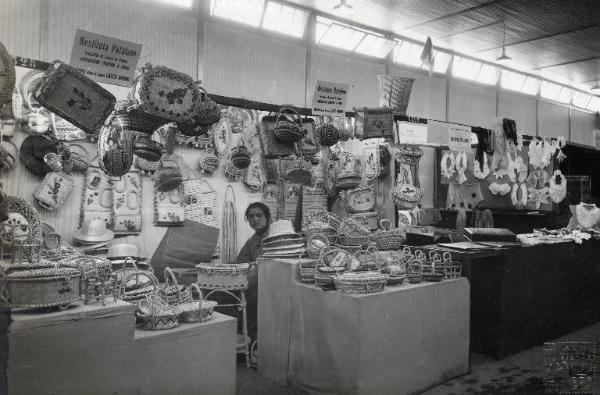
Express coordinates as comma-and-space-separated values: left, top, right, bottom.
47, 0, 198, 78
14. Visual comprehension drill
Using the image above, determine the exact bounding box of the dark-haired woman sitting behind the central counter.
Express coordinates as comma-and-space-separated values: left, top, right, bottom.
236, 202, 271, 348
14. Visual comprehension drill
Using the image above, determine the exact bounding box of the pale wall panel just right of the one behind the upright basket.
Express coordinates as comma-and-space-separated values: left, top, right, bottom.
448, 81, 496, 127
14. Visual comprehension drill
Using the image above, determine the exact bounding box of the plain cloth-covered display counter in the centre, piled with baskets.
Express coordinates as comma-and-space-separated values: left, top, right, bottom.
288, 278, 469, 394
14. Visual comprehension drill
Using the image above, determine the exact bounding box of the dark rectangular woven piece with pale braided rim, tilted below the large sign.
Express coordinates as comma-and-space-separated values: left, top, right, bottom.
35, 62, 116, 133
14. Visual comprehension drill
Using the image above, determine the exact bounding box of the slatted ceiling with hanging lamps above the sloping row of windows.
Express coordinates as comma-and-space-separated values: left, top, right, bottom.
288, 0, 600, 88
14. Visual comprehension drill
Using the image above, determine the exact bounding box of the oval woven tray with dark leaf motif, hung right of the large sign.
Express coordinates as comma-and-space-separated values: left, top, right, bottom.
131, 64, 201, 122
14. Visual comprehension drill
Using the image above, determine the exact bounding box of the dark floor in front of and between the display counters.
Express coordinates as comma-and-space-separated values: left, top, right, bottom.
237, 323, 600, 395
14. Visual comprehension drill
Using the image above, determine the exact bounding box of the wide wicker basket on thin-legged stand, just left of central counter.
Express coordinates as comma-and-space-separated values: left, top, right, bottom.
196, 263, 249, 289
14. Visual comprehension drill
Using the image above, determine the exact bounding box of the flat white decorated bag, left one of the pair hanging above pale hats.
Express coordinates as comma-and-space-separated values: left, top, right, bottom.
78, 166, 114, 229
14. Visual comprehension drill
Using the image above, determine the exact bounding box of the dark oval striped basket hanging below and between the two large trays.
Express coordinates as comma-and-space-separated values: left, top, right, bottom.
98, 113, 133, 177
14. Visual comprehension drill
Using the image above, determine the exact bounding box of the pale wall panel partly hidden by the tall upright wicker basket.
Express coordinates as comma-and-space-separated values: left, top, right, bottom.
390, 66, 446, 121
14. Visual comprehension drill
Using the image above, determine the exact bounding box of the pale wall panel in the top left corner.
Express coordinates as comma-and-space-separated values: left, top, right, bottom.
0, 0, 40, 59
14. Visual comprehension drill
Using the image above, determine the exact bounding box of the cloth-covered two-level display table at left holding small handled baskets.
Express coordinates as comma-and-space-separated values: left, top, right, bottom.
7, 298, 236, 395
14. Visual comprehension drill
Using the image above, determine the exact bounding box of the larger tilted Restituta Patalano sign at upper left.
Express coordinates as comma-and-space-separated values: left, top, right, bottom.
70, 29, 142, 86
